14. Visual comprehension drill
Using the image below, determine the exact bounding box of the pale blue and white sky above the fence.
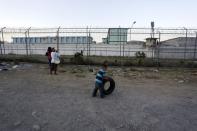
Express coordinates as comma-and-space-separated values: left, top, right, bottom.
0, 0, 197, 28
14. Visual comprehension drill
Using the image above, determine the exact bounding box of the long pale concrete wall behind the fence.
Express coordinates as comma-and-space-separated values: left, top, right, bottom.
5, 44, 154, 57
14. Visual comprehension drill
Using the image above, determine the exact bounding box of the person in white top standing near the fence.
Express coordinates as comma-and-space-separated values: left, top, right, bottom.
50, 48, 60, 74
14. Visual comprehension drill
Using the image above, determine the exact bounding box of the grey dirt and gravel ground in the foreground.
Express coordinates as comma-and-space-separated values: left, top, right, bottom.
0, 64, 197, 131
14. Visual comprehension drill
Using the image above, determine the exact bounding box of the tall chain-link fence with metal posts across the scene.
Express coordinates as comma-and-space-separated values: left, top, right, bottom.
0, 27, 197, 60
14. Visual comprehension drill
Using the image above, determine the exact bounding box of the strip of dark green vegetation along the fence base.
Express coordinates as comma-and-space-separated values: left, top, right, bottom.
0, 52, 197, 68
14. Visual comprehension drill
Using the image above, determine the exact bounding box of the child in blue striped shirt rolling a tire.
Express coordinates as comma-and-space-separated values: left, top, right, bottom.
92, 61, 108, 98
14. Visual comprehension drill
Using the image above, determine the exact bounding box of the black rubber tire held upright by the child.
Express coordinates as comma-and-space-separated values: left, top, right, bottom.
103, 77, 115, 95
